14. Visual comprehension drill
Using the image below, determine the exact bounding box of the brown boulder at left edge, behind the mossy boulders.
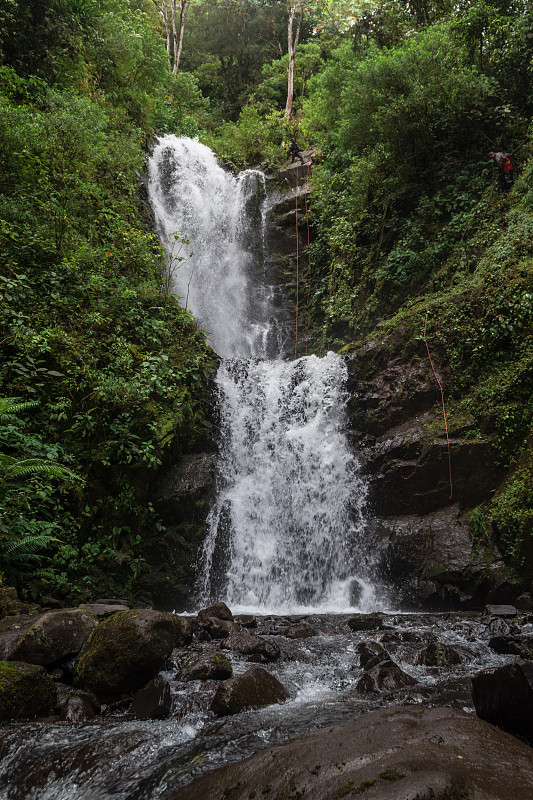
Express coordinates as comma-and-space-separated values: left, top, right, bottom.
0, 608, 98, 666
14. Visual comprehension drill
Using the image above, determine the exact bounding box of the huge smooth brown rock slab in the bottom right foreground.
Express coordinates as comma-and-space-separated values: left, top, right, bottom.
174, 706, 533, 800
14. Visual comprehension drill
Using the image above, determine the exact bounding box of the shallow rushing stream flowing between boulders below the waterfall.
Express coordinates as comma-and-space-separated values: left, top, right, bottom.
0, 613, 533, 800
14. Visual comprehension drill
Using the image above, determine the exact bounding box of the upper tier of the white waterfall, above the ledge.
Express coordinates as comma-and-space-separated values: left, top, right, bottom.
149, 136, 287, 358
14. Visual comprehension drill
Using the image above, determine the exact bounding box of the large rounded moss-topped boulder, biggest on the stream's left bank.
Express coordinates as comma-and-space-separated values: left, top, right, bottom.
76, 609, 182, 701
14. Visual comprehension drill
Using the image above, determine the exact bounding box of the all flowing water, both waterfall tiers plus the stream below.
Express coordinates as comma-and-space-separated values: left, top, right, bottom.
0, 141, 520, 800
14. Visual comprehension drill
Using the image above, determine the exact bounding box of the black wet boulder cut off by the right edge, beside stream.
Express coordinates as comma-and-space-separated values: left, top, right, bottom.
472, 661, 533, 741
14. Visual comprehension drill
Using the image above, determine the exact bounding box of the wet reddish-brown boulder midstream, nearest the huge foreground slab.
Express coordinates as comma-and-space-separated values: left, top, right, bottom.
211, 667, 289, 717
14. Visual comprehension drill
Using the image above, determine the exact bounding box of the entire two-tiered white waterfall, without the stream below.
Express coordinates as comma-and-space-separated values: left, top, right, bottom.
149, 136, 377, 613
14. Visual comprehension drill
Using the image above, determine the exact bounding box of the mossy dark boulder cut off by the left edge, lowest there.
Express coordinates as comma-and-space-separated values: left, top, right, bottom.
0, 661, 56, 722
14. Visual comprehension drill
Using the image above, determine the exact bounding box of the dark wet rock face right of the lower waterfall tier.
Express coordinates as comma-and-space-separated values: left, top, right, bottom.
348, 327, 513, 611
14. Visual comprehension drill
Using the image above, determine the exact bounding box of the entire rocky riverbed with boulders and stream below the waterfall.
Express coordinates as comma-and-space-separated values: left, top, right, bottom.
0, 601, 533, 800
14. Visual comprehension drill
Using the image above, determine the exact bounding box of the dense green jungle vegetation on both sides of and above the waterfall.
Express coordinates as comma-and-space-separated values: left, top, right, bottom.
0, 0, 533, 601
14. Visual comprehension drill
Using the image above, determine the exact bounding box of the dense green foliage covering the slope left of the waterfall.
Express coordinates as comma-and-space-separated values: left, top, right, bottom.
0, 0, 213, 600
